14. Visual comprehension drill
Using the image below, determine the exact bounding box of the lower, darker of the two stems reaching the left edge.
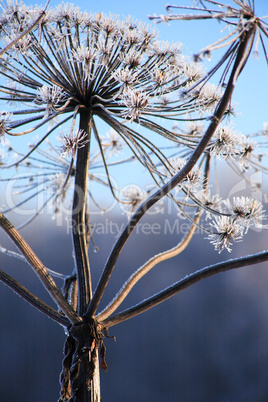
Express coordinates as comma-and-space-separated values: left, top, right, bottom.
0, 270, 70, 327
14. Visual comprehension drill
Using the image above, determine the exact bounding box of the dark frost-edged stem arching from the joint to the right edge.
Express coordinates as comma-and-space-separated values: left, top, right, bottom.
101, 251, 268, 328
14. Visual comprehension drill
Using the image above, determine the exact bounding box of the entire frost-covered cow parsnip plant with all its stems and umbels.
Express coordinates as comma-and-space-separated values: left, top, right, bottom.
0, 0, 268, 401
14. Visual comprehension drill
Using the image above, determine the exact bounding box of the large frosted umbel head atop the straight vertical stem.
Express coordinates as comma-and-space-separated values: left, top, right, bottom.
0, 2, 208, 154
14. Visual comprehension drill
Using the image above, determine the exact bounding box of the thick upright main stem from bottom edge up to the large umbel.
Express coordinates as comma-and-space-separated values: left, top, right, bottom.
60, 108, 101, 402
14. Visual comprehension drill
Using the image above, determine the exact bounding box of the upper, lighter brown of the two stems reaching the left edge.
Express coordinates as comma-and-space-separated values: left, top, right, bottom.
0, 213, 81, 324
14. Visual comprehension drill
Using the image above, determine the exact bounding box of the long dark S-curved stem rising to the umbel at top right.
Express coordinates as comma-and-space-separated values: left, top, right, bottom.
86, 26, 252, 316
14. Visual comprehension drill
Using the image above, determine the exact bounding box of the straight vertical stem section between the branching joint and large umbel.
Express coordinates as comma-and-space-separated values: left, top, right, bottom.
72, 109, 92, 316
